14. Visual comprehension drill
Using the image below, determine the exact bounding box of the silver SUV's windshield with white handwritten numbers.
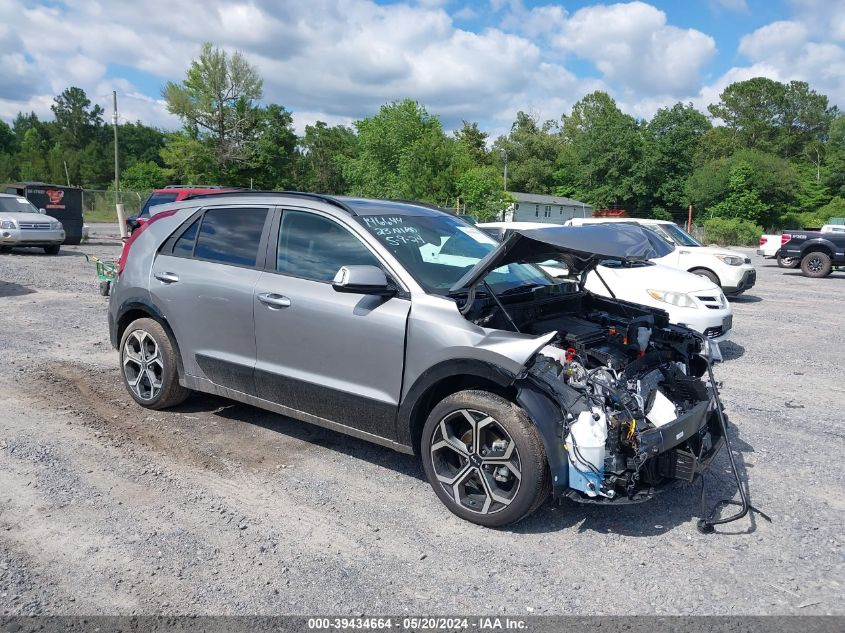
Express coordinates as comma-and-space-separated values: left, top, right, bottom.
359, 210, 555, 295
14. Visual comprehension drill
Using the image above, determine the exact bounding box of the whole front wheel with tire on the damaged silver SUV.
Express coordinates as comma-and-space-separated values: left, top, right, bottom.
420, 390, 551, 527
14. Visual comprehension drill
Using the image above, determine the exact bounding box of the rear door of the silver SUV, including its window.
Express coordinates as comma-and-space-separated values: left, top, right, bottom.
149, 207, 270, 393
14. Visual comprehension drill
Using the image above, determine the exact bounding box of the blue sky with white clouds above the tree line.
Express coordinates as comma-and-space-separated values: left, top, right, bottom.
0, 0, 845, 134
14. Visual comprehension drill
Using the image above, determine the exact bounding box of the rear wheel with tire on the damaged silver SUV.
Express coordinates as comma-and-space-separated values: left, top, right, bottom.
120, 318, 191, 409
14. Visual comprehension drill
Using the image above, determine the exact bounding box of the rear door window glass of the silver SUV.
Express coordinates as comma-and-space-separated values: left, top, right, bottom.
194, 208, 267, 266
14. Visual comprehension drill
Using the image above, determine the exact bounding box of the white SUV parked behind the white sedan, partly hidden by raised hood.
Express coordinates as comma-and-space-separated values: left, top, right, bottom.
566, 218, 757, 297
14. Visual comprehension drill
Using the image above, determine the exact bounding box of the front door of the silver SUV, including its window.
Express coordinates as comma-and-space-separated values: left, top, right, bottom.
249, 209, 411, 439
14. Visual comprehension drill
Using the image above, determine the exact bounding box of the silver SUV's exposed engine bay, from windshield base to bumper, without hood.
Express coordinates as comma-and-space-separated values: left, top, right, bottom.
462, 282, 723, 502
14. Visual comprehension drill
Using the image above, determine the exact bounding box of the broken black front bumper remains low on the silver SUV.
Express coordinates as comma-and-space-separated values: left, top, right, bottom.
555, 398, 725, 505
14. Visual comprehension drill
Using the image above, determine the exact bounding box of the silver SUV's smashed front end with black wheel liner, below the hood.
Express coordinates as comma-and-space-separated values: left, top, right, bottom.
517, 306, 724, 503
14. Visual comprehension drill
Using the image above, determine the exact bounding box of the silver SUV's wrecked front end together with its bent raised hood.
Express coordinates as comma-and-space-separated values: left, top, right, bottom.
452, 226, 726, 503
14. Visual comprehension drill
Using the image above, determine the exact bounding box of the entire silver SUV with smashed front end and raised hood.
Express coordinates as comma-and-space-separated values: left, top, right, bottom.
109, 192, 724, 526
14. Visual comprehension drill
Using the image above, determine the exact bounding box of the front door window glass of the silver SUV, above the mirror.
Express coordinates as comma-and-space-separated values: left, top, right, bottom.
276, 211, 381, 281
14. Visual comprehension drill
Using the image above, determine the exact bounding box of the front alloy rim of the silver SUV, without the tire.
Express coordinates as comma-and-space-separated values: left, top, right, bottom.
430, 409, 522, 514
